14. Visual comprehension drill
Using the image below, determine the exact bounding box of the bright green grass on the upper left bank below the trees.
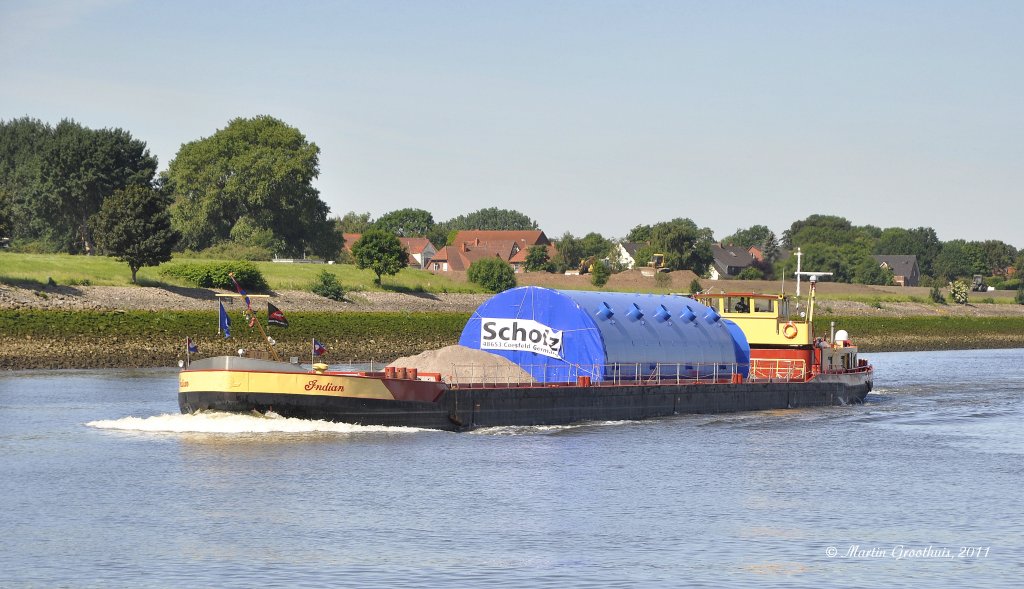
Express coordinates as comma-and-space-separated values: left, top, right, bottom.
0, 252, 483, 293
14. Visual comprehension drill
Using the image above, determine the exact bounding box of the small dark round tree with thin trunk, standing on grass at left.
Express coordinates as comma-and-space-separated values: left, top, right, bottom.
92, 186, 179, 284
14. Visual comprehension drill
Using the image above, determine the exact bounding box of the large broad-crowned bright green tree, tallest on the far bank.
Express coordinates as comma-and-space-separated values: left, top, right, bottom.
163, 116, 341, 258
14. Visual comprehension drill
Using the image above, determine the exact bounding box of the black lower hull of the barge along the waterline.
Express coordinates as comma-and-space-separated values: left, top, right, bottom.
178, 370, 871, 431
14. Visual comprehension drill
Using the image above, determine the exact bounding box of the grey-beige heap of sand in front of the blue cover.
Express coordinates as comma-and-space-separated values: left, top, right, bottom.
388, 345, 535, 384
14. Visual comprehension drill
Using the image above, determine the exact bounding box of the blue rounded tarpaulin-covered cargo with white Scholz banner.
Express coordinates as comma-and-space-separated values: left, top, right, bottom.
459, 287, 750, 382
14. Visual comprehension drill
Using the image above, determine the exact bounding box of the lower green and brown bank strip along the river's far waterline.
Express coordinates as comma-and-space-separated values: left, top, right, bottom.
0, 310, 1024, 370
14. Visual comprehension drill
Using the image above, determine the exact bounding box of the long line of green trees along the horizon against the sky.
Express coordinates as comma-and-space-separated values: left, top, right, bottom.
0, 116, 1024, 287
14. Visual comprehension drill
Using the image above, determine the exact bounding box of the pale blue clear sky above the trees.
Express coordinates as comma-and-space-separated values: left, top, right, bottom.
0, 0, 1024, 243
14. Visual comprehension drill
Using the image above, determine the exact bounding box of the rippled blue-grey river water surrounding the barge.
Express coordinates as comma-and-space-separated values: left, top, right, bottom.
0, 349, 1024, 588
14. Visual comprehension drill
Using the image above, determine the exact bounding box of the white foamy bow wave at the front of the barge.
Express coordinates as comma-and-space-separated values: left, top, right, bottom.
86, 412, 429, 433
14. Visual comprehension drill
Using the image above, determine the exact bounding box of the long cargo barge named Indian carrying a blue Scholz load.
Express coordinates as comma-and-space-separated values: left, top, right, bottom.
178, 278, 873, 431
